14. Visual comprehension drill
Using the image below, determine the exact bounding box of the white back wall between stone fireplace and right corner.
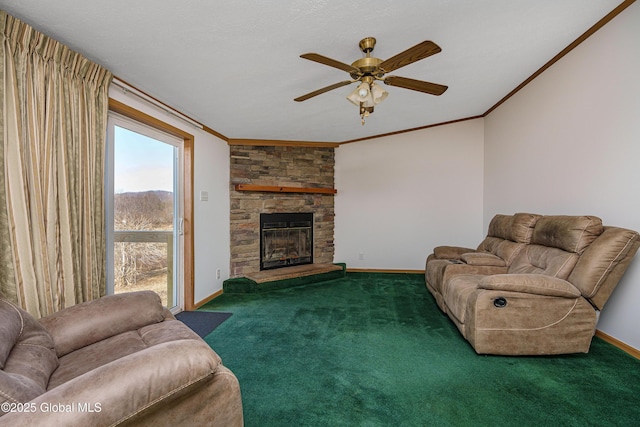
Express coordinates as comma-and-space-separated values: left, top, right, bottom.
334, 117, 484, 270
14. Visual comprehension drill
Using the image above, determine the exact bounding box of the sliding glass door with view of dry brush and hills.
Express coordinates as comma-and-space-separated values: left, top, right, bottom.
106, 114, 183, 311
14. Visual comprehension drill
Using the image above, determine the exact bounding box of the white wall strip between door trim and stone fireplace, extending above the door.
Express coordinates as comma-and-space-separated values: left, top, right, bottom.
109, 85, 231, 303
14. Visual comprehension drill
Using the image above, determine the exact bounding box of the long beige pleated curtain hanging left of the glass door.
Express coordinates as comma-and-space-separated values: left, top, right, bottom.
0, 11, 112, 317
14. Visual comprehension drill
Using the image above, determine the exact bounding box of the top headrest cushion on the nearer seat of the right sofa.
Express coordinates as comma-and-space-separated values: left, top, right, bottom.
531, 215, 604, 254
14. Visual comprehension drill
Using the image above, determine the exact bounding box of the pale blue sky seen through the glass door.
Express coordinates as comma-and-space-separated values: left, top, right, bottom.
113, 126, 174, 193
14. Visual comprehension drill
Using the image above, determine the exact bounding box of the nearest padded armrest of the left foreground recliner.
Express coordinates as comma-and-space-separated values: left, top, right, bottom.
0, 340, 219, 427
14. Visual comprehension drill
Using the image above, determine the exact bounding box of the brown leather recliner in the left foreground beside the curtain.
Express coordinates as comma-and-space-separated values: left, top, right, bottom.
0, 291, 243, 426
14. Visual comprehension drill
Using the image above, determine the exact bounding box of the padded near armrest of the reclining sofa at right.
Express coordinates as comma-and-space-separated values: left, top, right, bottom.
478, 274, 581, 298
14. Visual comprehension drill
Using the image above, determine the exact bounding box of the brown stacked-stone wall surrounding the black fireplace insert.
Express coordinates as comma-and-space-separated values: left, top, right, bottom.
230, 145, 335, 277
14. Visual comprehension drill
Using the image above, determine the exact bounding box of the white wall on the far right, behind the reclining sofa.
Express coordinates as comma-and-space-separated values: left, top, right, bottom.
484, 3, 640, 349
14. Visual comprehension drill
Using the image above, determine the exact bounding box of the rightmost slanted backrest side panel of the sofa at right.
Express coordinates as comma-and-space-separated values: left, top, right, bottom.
568, 227, 640, 310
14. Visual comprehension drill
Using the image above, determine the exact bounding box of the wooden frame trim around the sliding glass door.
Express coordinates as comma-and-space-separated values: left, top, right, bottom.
109, 98, 195, 311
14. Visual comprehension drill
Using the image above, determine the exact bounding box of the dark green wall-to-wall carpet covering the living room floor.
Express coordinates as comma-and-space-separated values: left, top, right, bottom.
203, 273, 640, 427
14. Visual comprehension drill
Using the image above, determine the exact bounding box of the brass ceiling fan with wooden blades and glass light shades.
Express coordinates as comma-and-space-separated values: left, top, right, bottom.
294, 37, 447, 125
